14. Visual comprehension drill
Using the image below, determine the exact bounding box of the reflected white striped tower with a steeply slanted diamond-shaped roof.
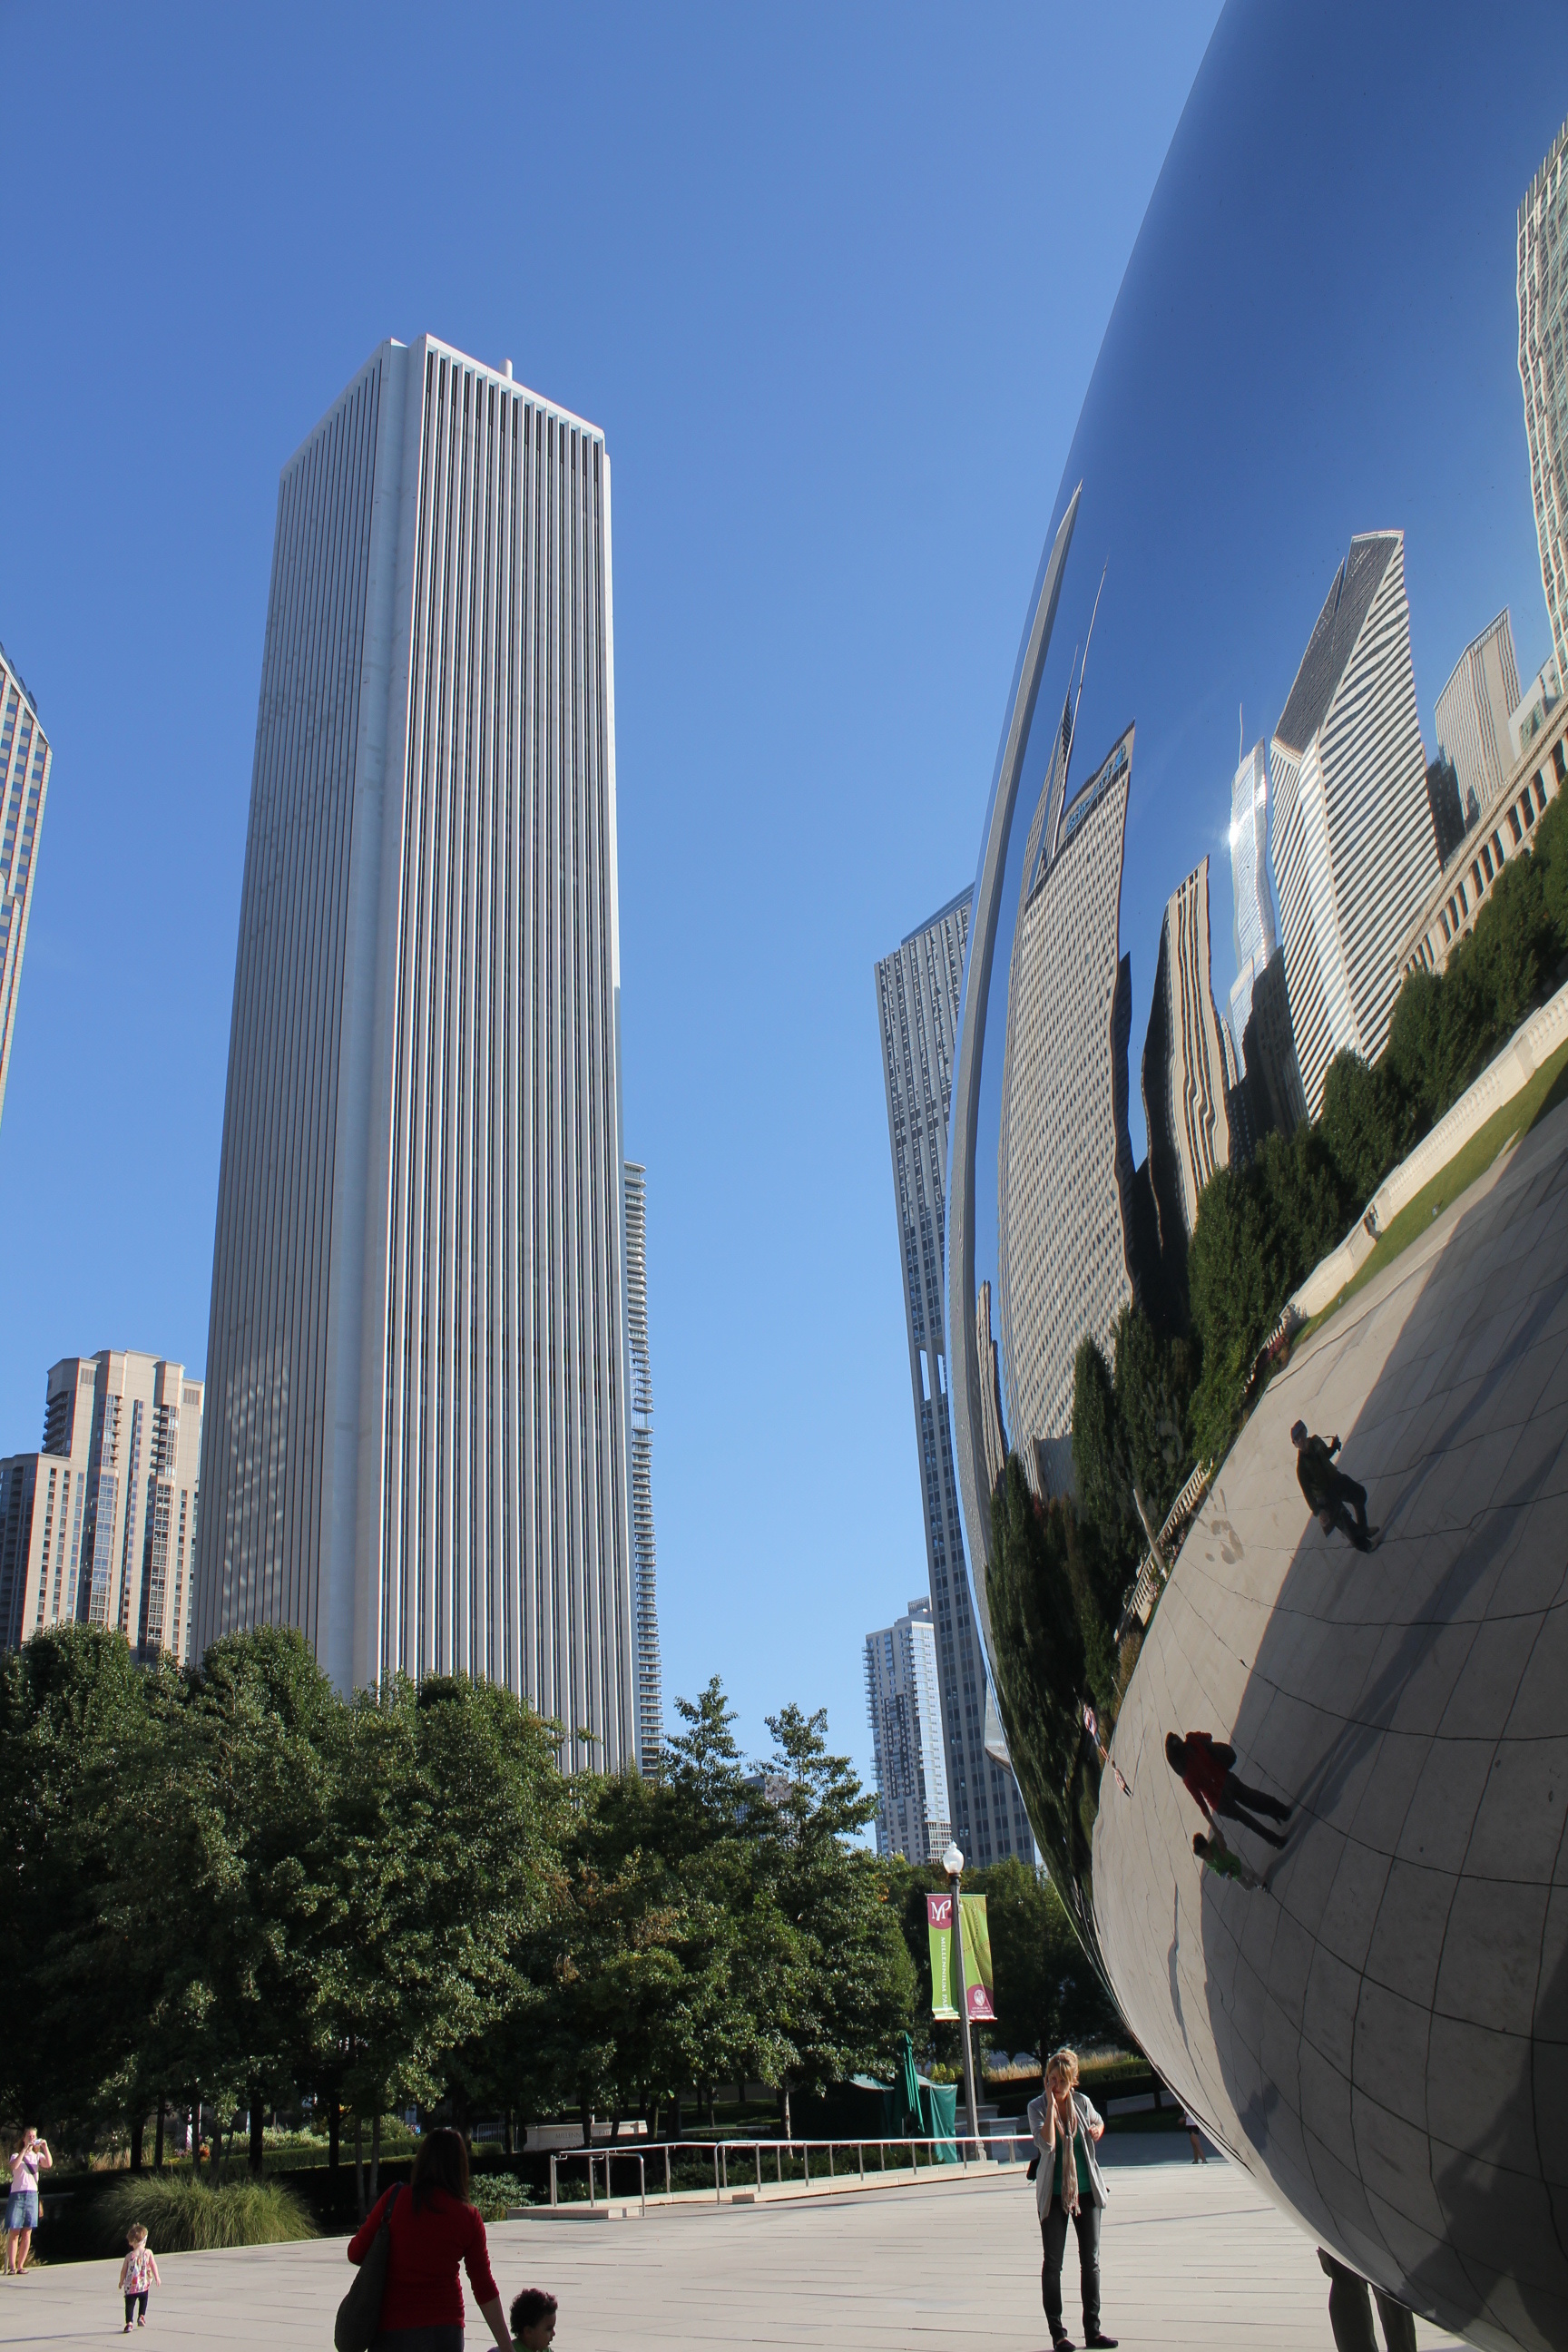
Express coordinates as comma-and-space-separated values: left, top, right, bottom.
1269, 532, 1439, 1117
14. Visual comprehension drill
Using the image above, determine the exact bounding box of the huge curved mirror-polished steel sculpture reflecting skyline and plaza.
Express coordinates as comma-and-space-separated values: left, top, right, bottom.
947, 0, 1568, 2347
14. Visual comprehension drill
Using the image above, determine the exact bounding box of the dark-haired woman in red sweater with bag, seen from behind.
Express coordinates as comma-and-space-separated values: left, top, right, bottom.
348, 2129, 513, 2352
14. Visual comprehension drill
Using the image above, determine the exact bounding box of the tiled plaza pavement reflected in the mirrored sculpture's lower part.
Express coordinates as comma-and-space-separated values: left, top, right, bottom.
1093, 1108, 1568, 2345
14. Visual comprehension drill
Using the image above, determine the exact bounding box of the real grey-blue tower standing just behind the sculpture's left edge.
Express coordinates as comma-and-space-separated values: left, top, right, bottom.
877, 891, 1034, 1867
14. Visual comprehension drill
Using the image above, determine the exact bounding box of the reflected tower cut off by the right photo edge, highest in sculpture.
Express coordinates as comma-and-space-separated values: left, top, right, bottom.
1519, 122, 1568, 677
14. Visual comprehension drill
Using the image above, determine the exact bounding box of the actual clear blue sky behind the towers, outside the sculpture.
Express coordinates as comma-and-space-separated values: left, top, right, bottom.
0, 0, 1222, 1769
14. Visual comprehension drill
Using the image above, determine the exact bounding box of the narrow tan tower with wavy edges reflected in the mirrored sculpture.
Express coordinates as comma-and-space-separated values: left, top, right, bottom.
1142, 858, 1250, 1263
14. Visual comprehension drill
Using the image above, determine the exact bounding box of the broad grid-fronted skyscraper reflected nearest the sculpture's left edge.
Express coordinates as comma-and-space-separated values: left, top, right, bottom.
996, 727, 1133, 1494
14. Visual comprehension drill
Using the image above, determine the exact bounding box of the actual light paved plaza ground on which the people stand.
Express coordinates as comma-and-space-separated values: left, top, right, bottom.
0, 2138, 1475, 2352
